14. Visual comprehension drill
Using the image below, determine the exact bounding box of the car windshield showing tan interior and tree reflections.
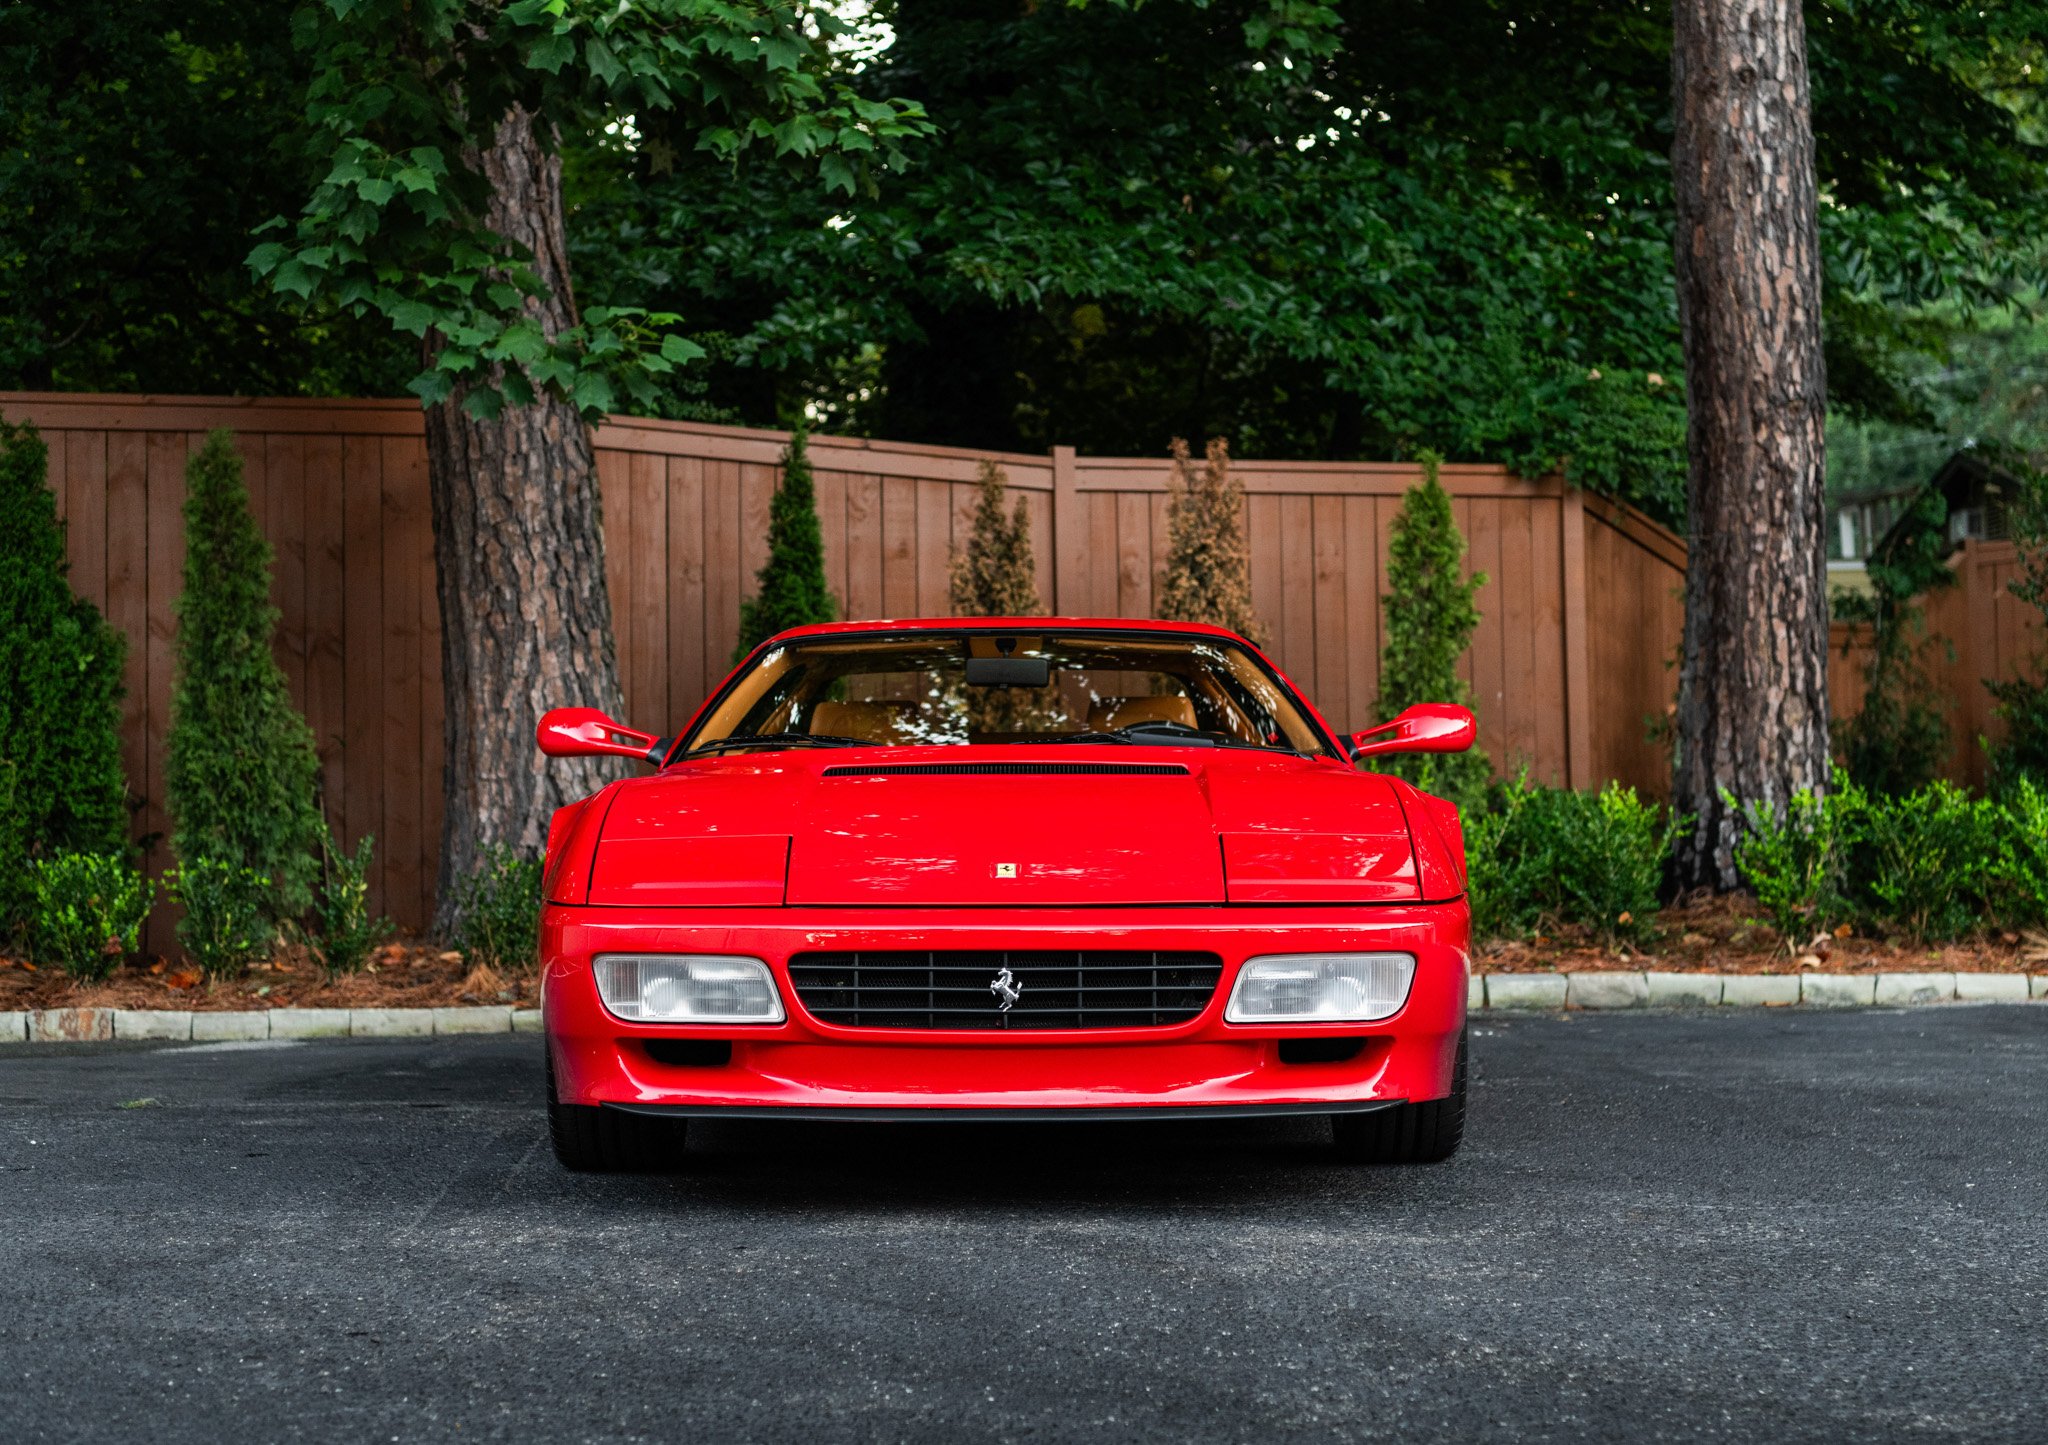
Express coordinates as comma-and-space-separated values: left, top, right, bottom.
682, 632, 1329, 755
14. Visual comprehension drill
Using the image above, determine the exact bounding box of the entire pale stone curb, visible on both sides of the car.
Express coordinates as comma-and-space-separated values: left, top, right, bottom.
0, 970, 2048, 1044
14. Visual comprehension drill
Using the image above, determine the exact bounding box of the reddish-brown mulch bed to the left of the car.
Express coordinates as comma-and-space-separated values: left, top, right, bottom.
0, 939, 541, 1011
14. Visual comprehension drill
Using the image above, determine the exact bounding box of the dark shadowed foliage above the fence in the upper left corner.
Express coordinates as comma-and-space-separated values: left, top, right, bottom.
0, 0, 412, 397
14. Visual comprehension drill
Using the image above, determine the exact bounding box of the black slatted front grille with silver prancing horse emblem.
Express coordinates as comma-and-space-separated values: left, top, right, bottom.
788, 950, 1223, 1030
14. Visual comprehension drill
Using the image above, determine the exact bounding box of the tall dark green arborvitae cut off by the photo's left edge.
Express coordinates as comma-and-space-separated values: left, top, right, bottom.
0, 422, 127, 933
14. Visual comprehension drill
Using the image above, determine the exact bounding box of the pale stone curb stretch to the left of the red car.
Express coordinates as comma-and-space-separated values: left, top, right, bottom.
0, 1005, 541, 1044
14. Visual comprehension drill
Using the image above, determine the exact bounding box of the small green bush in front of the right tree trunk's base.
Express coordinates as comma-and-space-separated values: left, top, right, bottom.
1724, 770, 1864, 952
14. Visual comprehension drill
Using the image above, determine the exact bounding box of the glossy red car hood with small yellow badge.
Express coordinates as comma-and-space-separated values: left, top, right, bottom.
590, 747, 1427, 907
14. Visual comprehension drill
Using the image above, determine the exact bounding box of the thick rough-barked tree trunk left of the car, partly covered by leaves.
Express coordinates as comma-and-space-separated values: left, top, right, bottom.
426, 108, 621, 935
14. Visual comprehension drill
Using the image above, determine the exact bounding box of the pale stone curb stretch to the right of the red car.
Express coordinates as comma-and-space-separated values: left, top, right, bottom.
1464, 972, 2048, 1009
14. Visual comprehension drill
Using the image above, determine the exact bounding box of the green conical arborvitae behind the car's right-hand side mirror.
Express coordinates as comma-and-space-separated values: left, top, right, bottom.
1372, 452, 1493, 804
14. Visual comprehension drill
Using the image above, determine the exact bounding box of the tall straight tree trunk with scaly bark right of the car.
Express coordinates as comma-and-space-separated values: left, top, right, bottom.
1671, 0, 1829, 890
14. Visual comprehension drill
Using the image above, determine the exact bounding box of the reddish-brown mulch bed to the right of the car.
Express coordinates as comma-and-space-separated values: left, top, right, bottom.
1473, 894, 2048, 974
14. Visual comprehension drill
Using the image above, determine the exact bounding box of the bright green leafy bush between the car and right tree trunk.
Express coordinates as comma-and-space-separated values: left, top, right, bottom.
1464, 772, 1679, 944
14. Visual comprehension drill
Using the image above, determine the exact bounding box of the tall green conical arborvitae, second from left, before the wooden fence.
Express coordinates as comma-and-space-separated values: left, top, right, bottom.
164, 432, 324, 919
